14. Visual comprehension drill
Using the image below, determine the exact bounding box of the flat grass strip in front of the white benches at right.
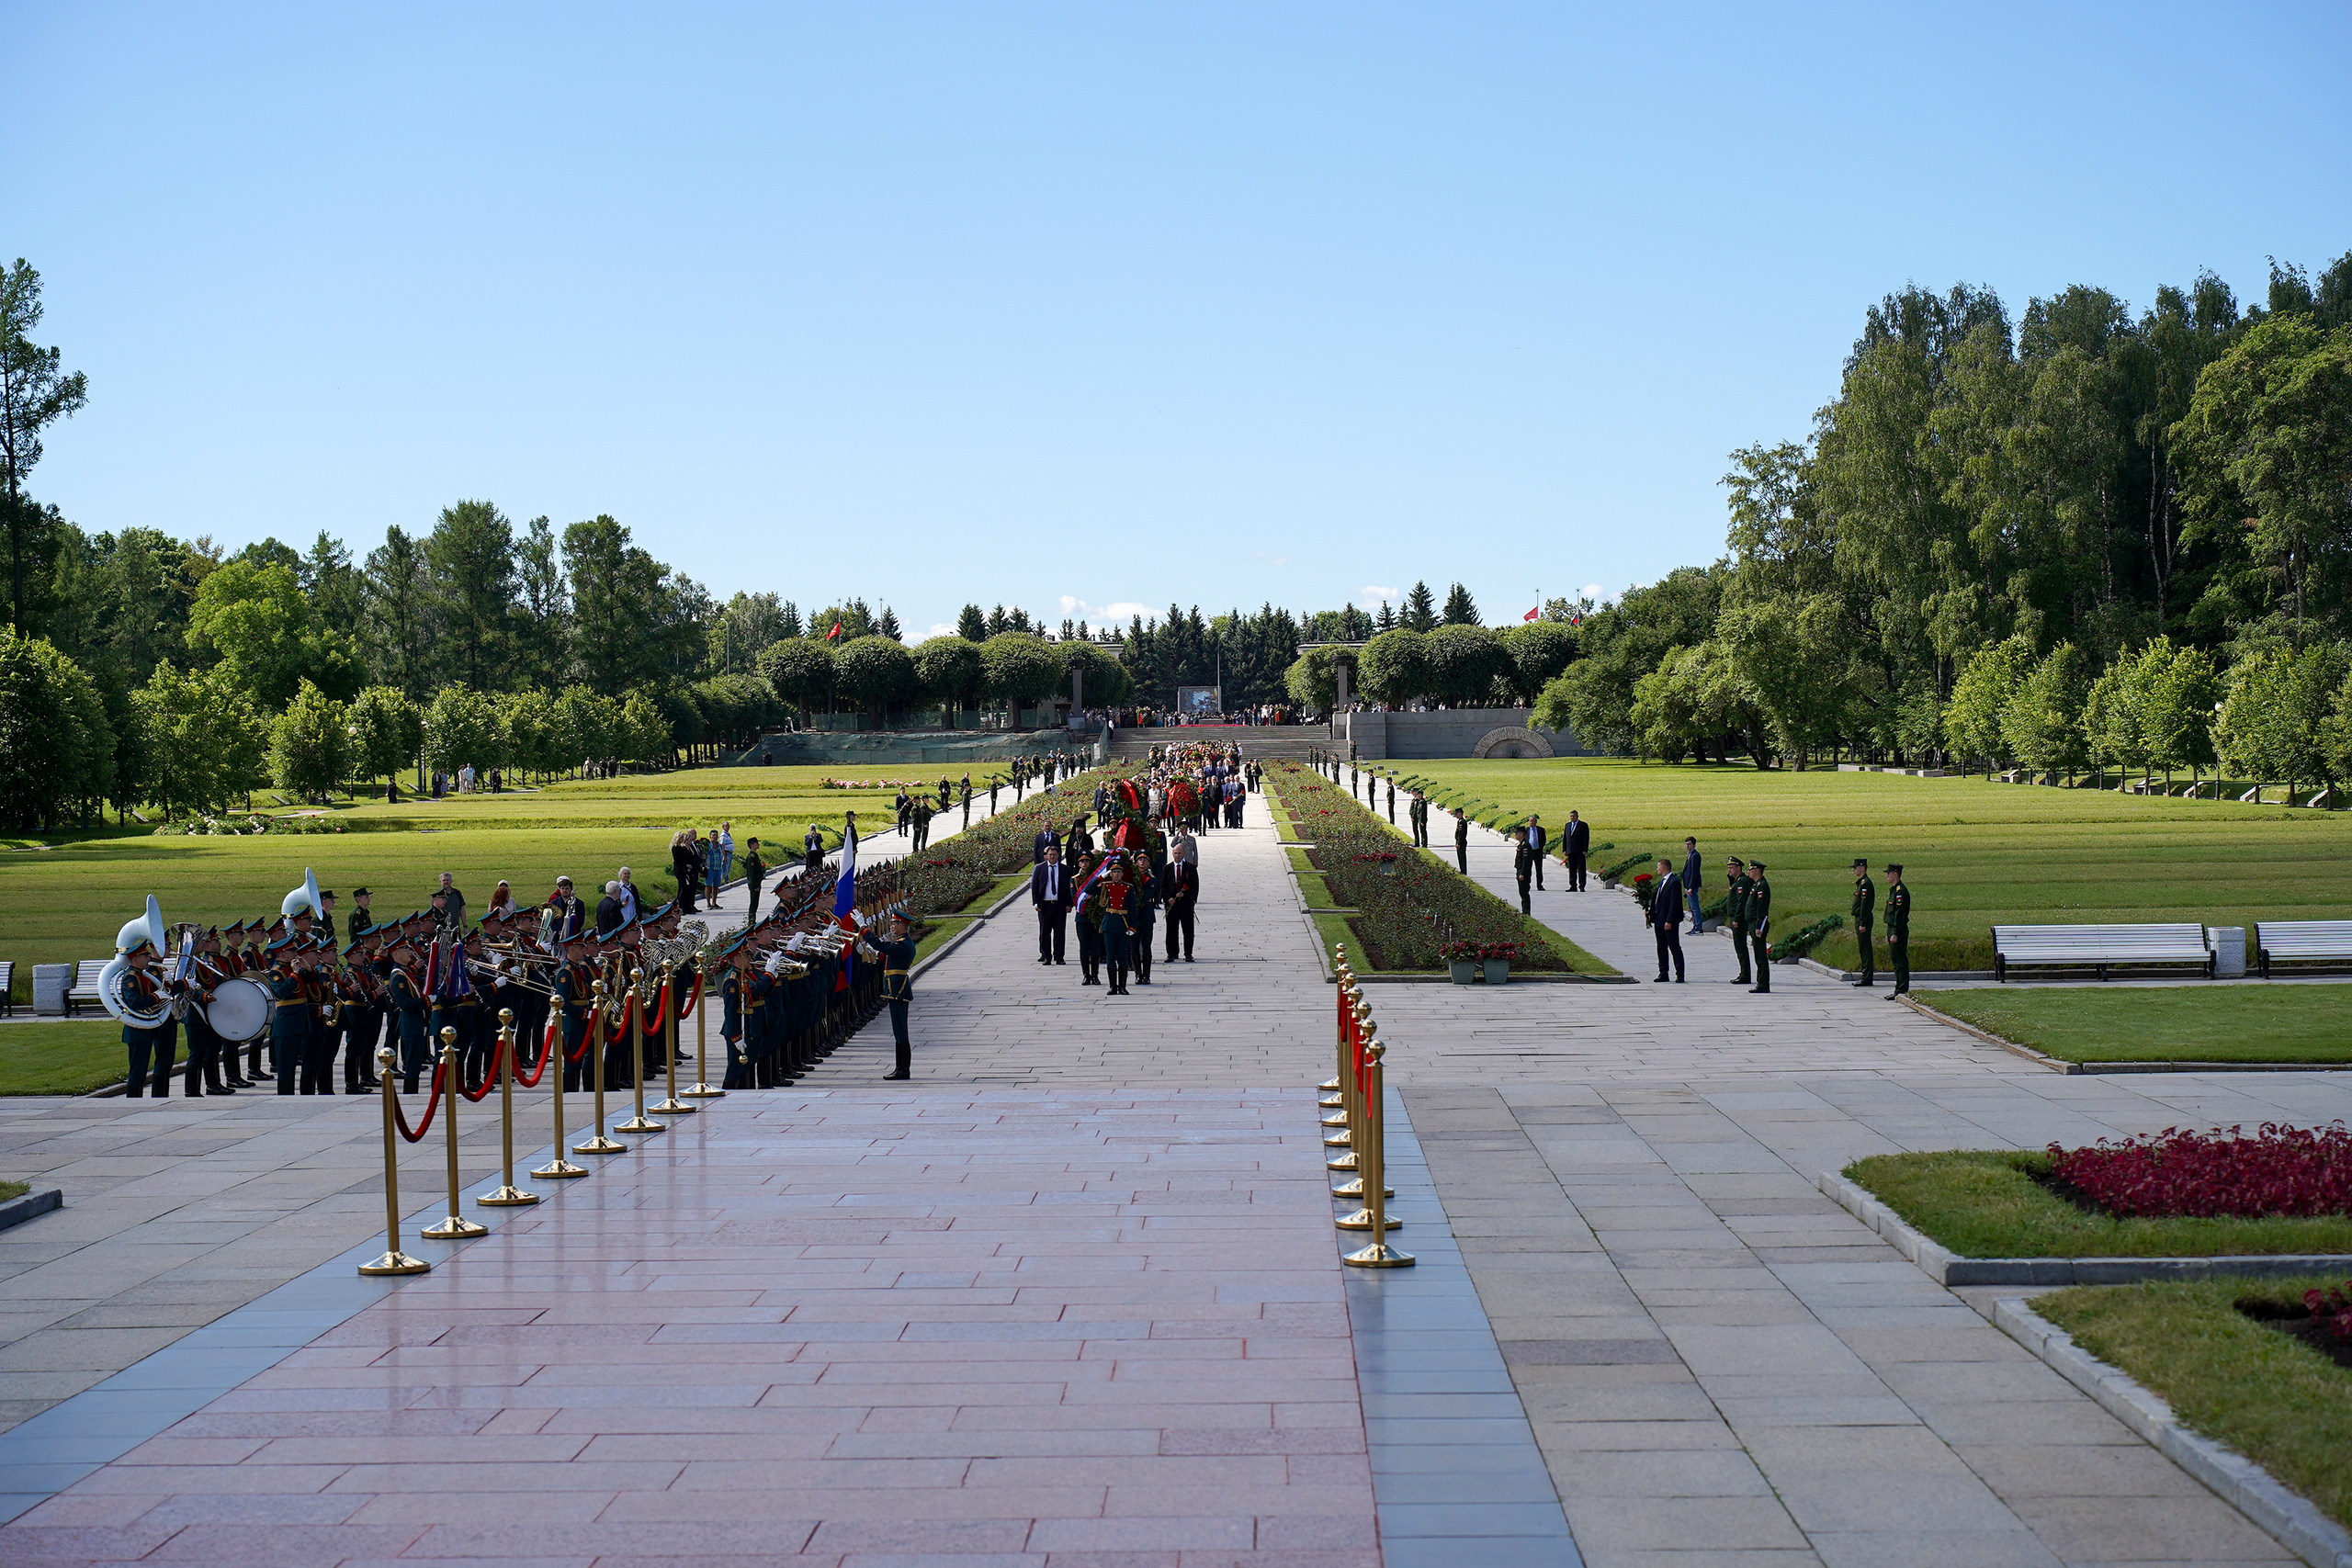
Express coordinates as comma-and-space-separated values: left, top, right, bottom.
1912, 985, 2352, 1063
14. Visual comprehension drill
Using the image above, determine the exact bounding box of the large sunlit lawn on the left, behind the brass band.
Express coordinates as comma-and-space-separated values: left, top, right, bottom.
0, 766, 1012, 1001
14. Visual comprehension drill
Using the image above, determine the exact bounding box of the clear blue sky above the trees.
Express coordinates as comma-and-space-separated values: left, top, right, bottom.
18, 0, 2352, 635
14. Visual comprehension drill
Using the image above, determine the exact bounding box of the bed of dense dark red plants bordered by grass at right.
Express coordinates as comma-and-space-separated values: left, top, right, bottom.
2049, 1122, 2352, 1218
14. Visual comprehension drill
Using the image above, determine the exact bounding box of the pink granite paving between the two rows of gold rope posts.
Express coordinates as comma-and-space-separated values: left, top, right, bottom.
0, 1089, 1378, 1568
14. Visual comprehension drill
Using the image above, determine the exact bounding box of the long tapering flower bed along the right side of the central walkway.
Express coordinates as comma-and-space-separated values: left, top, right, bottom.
1265, 761, 1609, 974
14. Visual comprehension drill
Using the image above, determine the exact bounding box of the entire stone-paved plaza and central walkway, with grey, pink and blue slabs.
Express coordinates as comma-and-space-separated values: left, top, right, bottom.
0, 802, 2352, 1568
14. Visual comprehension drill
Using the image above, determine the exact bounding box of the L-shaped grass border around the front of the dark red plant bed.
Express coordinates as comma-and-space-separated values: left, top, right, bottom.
1847, 1149, 2352, 1258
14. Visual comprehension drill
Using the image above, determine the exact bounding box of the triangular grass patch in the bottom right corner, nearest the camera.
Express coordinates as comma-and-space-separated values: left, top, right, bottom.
2030, 1279, 2352, 1526
